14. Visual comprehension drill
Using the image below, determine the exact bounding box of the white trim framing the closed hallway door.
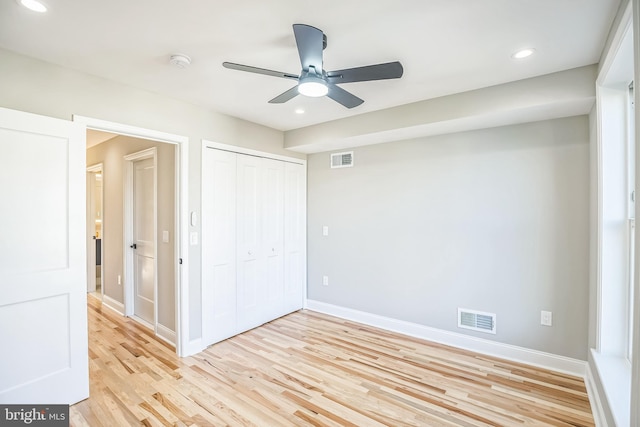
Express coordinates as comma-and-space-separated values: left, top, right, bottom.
122, 147, 158, 334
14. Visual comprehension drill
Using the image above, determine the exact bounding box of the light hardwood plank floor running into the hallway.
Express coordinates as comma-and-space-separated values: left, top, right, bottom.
70, 297, 594, 427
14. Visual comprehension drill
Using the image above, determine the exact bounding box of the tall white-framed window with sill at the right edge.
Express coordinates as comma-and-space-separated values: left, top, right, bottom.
591, 12, 640, 425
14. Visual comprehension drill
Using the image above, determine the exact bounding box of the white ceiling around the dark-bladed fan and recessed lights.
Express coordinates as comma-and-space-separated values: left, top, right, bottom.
0, 0, 620, 130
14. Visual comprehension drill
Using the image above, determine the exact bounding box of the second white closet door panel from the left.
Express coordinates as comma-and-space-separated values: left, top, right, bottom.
236, 154, 266, 332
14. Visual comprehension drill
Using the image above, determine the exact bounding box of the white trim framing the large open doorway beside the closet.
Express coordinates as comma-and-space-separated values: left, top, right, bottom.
73, 115, 189, 357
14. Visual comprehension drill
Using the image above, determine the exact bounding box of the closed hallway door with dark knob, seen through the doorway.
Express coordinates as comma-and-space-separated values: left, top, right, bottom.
131, 158, 156, 327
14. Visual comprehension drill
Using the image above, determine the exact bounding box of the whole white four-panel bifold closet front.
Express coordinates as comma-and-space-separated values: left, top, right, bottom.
202, 144, 306, 345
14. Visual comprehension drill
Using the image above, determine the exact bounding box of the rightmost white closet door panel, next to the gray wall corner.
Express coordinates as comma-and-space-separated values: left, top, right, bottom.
283, 163, 307, 313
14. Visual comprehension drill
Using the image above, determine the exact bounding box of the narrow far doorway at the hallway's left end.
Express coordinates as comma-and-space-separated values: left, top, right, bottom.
87, 163, 104, 301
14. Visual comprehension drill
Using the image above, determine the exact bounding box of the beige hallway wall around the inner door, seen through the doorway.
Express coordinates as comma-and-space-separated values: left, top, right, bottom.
87, 136, 176, 332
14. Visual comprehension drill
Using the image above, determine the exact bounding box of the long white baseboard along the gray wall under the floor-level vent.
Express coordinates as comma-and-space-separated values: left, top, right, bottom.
305, 300, 587, 378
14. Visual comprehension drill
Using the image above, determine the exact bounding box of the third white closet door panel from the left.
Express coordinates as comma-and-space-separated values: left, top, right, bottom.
262, 159, 285, 321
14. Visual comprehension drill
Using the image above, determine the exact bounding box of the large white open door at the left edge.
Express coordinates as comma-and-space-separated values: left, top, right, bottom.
0, 108, 89, 404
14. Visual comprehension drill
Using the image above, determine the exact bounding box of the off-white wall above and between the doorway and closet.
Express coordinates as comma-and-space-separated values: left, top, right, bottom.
0, 49, 305, 340
